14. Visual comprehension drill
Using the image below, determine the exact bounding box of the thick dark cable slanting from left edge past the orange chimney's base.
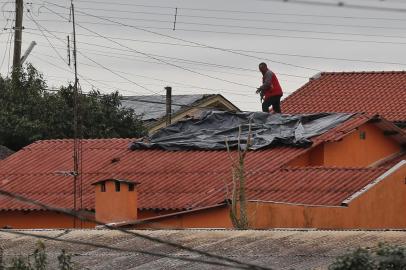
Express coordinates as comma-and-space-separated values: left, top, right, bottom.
0, 189, 270, 270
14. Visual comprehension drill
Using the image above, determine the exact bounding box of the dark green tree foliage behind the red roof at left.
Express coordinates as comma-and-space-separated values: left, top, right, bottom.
0, 65, 146, 150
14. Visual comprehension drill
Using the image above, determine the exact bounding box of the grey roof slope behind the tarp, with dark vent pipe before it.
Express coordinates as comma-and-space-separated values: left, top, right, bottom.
121, 94, 215, 121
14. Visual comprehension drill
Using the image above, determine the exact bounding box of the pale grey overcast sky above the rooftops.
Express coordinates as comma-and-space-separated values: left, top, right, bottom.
0, 0, 406, 111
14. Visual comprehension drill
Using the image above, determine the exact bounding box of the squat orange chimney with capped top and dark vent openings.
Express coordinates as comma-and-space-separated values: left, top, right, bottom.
92, 179, 138, 223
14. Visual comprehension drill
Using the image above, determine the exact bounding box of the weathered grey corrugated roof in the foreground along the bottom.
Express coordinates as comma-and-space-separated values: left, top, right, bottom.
0, 230, 406, 270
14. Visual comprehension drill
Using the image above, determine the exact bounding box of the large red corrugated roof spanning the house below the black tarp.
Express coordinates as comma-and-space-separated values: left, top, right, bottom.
0, 114, 402, 210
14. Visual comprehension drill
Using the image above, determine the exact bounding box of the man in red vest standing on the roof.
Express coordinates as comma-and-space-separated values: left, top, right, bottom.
256, 63, 283, 113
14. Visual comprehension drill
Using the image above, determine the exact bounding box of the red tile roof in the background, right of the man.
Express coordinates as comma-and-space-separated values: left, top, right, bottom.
282, 71, 406, 122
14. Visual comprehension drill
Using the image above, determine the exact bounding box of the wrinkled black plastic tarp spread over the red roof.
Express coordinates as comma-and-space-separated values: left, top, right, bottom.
130, 111, 353, 151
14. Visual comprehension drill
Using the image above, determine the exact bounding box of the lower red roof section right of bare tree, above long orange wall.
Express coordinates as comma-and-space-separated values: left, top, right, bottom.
247, 167, 387, 206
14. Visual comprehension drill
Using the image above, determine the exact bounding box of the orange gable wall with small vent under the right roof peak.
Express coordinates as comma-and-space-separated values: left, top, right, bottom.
289, 124, 401, 167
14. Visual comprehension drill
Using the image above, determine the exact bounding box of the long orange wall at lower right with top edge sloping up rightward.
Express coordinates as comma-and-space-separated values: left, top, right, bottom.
249, 165, 406, 229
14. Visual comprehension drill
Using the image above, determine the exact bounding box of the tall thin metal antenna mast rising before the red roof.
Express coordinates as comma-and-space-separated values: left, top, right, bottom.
71, 0, 82, 228
